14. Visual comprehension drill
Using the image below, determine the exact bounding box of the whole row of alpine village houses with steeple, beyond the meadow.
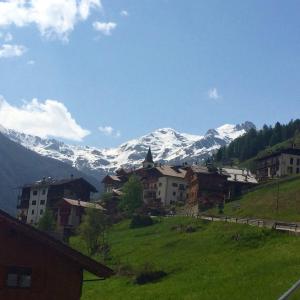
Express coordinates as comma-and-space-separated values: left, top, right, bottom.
17, 148, 300, 232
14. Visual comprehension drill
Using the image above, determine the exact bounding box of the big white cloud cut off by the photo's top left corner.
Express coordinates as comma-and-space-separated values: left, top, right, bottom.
0, 0, 102, 40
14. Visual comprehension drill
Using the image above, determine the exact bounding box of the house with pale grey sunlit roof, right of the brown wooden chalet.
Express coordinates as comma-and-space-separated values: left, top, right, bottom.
221, 167, 258, 200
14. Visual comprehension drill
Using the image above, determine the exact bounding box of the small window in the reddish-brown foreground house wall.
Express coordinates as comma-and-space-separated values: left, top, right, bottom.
6, 267, 32, 288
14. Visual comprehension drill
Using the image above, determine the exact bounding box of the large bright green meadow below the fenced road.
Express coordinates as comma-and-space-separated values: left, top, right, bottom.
71, 217, 300, 300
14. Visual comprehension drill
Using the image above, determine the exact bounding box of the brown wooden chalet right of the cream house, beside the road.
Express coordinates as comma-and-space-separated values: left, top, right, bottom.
185, 165, 229, 213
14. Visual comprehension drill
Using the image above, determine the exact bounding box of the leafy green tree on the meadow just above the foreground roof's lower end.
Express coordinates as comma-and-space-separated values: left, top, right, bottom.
78, 208, 109, 258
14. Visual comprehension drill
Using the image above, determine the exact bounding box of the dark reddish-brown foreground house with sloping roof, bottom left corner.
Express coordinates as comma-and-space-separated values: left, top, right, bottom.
0, 210, 113, 300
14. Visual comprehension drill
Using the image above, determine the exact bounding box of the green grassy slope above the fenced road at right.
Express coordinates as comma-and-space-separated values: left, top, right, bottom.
210, 176, 300, 222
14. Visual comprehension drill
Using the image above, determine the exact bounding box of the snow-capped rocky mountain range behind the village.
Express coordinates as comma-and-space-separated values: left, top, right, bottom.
0, 122, 255, 177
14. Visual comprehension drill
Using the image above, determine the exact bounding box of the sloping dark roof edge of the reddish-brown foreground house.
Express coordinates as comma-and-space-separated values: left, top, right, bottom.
0, 210, 113, 278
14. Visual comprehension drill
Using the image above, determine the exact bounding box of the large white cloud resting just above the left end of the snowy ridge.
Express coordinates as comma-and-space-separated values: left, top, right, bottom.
0, 97, 90, 141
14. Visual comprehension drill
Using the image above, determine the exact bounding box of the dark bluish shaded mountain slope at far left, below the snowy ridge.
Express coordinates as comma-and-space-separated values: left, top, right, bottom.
0, 133, 100, 214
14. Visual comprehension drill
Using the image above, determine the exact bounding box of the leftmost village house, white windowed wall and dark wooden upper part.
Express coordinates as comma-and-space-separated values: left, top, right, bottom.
17, 176, 97, 224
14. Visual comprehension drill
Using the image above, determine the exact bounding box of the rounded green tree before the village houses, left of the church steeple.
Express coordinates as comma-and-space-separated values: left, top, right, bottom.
120, 175, 143, 215
